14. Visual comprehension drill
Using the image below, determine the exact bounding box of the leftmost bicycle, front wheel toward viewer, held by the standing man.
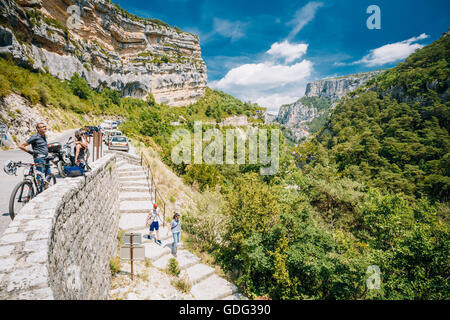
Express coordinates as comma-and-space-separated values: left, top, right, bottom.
3, 159, 56, 220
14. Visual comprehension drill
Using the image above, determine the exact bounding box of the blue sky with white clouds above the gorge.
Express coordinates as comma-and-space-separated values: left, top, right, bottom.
113, 0, 450, 114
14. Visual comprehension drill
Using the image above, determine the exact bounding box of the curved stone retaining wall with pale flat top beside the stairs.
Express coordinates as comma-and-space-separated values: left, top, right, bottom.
0, 154, 120, 300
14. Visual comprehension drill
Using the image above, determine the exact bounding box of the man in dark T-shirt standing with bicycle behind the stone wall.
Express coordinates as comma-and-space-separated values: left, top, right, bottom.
19, 122, 50, 183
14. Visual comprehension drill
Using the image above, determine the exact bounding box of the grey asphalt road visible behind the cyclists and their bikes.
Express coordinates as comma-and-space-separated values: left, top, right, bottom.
0, 130, 98, 236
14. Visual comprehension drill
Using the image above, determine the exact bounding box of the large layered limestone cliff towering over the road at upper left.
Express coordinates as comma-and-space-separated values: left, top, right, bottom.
0, 0, 207, 106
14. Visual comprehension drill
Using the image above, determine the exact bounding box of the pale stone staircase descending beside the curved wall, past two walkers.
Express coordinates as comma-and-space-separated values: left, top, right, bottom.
117, 160, 246, 300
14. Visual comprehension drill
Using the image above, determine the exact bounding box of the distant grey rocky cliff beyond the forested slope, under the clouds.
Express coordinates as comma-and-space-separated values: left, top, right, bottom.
274, 70, 383, 142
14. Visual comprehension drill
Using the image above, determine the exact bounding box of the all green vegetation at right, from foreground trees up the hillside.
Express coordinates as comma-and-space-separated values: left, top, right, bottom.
173, 31, 450, 299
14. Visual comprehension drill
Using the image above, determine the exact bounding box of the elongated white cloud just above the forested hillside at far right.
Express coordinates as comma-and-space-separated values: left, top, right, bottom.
356, 33, 429, 67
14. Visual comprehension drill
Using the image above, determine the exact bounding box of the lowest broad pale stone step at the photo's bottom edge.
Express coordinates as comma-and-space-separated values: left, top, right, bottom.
191, 274, 237, 300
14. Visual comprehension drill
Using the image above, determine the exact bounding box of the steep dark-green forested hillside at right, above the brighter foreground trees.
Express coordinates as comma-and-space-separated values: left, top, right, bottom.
299, 30, 450, 201
